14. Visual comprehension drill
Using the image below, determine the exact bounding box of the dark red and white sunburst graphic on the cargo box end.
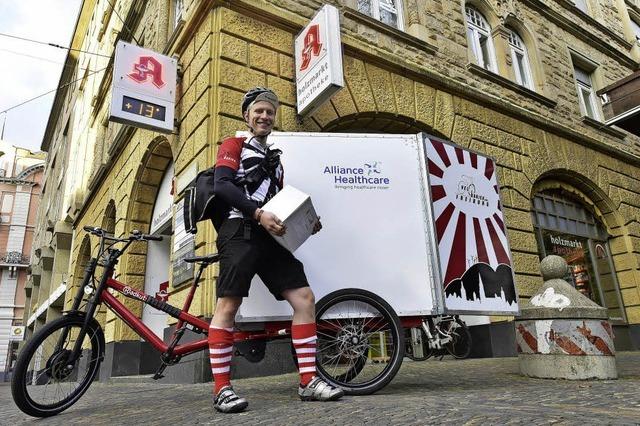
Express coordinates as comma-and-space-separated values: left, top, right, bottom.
427, 139, 511, 288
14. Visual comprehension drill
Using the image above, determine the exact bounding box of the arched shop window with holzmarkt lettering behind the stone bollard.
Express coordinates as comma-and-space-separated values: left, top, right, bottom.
531, 190, 626, 321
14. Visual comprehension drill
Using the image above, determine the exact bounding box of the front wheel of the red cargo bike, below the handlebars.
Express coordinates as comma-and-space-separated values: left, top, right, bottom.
11, 315, 104, 417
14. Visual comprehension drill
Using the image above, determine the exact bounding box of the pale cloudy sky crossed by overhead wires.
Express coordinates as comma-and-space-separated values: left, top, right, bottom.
0, 0, 82, 151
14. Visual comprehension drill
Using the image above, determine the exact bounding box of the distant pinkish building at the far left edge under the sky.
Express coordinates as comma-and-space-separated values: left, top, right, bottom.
0, 140, 45, 382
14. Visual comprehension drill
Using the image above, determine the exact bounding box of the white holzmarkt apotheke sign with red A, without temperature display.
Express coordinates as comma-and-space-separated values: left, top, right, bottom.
295, 5, 344, 115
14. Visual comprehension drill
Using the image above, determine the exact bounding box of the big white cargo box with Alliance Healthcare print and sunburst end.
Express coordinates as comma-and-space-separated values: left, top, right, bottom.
237, 133, 518, 322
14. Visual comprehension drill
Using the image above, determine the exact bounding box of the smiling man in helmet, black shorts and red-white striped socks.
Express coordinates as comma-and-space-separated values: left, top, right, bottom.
209, 87, 343, 413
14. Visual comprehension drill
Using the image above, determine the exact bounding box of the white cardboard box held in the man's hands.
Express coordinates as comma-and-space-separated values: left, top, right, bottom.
262, 185, 318, 252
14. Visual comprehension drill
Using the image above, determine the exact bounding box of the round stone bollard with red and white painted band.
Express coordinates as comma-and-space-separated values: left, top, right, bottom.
516, 256, 618, 380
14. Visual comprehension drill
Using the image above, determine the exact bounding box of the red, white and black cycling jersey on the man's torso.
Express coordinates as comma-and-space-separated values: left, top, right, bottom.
216, 137, 284, 219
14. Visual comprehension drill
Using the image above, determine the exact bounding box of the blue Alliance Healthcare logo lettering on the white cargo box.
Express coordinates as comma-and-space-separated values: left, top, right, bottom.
322, 161, 391, 190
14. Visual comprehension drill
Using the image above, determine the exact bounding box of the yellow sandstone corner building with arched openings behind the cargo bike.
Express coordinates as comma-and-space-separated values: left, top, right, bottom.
25, 0, 640, 381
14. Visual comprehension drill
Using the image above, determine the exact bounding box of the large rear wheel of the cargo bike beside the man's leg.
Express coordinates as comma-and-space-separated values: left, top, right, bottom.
316, 289, 404, 395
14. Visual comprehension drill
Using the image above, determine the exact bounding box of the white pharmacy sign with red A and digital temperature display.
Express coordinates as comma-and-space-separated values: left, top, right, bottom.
109, 41, 178, 133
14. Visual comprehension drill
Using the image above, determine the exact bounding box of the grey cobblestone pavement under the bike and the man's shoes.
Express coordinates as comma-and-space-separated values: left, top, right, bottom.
0, 352, 640, 425
